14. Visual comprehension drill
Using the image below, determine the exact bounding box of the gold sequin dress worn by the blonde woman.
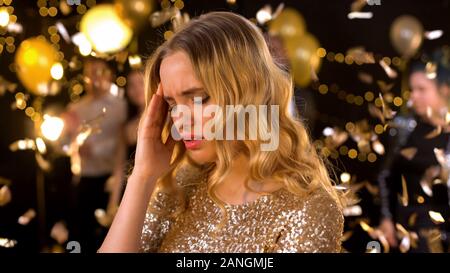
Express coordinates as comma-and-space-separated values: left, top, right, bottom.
141, 167, 344, 252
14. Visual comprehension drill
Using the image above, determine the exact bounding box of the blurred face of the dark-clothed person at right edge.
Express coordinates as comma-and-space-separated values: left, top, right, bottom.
409, 72, 447, 117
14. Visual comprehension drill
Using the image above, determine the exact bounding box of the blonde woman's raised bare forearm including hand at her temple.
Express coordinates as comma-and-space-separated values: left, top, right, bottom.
99, 85, 175, 252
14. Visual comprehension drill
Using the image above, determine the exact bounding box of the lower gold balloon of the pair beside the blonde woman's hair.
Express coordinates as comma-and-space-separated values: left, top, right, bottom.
284, 33, 321, 87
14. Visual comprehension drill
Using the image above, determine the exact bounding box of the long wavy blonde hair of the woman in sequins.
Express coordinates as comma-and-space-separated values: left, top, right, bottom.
145, 12, 343, 219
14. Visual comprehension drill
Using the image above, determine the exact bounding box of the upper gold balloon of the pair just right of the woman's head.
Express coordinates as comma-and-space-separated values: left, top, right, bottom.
269, 8, 306, 39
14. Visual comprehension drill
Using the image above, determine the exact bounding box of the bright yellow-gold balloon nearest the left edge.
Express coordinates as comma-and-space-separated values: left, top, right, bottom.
15, 36, 57, 96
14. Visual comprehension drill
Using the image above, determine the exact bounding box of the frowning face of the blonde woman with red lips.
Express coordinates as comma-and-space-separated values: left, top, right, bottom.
159, 51, 216, 164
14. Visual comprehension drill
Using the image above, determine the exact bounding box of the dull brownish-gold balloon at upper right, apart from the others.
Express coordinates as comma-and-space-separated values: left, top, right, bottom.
390, 15, 423, 58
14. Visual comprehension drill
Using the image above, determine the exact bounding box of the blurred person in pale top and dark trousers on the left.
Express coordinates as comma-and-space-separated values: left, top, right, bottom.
63, 58, 127, 252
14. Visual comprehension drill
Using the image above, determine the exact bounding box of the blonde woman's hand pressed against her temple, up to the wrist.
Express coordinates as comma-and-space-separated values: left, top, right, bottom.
132, 84, 175, 181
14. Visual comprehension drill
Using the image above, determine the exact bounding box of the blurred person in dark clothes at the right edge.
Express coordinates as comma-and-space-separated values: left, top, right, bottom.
378, 47, 450, 252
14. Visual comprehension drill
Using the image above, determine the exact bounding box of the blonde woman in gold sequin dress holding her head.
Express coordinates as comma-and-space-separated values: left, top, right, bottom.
99, 12, 343, 252
